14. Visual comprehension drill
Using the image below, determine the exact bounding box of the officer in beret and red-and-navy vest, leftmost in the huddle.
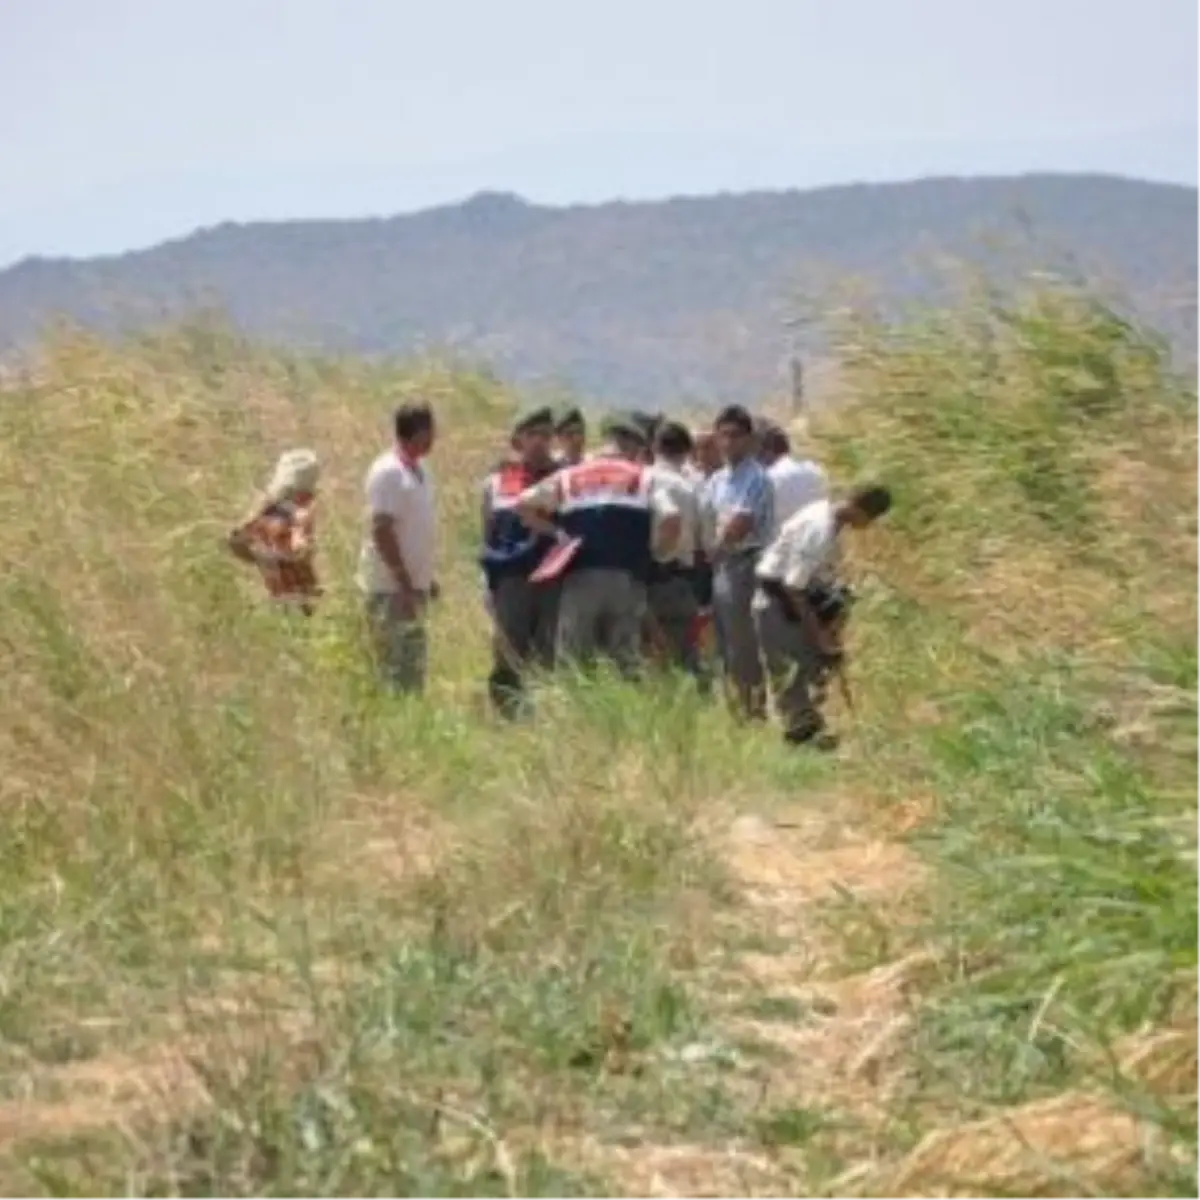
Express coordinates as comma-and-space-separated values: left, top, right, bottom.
480, 408, 560, 716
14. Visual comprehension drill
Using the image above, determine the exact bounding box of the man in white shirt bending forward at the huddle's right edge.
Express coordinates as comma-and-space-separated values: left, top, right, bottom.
754, 486, 892, 746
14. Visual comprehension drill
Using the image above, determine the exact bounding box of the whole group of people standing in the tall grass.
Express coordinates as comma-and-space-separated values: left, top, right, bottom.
229, 403, 892, 745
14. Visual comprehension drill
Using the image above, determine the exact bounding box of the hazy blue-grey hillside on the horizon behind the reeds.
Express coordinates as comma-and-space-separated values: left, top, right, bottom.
7, 175, 1200, 407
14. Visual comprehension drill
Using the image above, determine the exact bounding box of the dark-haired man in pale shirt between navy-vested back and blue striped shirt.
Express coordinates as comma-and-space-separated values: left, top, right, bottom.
648, 421, 712, 689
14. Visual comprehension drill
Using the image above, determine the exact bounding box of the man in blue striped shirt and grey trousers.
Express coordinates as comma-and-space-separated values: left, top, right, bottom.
704, 404, 775, 719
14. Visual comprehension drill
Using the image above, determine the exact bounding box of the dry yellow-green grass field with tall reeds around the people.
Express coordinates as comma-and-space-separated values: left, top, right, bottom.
0, 280, 1200, 1198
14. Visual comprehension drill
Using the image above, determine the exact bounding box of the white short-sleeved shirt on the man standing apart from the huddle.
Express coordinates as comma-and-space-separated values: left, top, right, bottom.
359, 449, 437, 594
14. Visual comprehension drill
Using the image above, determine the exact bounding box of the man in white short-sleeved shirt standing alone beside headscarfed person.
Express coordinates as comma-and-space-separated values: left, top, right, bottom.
358, 404, 438, 692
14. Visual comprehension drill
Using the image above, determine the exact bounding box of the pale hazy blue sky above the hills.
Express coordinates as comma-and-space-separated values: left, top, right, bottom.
0, 0, 1200, 265
